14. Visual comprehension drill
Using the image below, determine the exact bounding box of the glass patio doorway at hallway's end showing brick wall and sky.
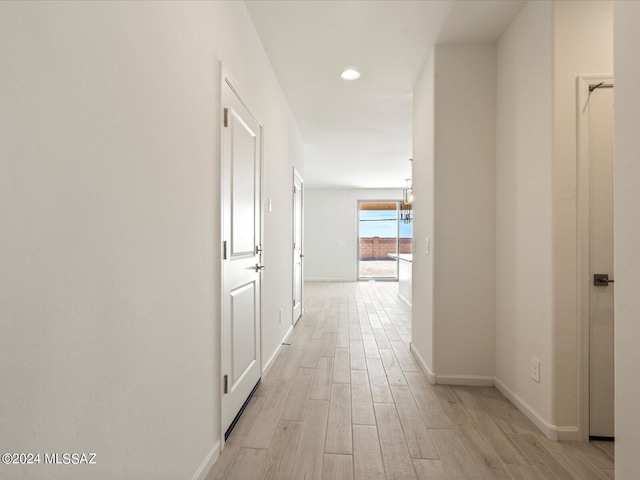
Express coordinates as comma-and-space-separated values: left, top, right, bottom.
358, 200, 412, 281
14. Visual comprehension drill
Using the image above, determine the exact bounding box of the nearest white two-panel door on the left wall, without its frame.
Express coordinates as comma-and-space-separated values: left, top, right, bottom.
222, 79, 262, 431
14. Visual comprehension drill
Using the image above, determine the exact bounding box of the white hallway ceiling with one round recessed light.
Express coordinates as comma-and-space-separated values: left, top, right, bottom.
245, 0, 525, 188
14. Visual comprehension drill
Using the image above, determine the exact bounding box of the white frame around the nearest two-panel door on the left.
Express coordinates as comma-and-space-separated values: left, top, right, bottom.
217, 66, 265, 452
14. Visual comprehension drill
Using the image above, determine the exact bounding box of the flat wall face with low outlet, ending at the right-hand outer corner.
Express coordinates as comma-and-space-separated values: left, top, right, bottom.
496, 2, 553, 423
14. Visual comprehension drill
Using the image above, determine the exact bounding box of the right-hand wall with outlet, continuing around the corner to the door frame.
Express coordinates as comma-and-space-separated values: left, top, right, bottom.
496, 1, 613, 438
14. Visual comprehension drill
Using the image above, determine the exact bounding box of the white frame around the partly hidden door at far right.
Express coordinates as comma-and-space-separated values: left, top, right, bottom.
576, 75, 614, 442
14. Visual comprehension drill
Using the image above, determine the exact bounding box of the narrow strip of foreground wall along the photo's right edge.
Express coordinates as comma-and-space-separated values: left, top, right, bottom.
614, 2, 640, 480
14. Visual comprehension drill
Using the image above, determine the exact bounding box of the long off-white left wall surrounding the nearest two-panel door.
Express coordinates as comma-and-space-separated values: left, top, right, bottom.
0, 2, 302, 479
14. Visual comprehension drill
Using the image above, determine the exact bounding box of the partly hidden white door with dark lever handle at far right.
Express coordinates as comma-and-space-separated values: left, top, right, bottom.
589, 88, 615, 437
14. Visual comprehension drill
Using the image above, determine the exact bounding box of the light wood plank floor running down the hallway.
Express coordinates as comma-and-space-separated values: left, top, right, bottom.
207, 282, 614, 480
